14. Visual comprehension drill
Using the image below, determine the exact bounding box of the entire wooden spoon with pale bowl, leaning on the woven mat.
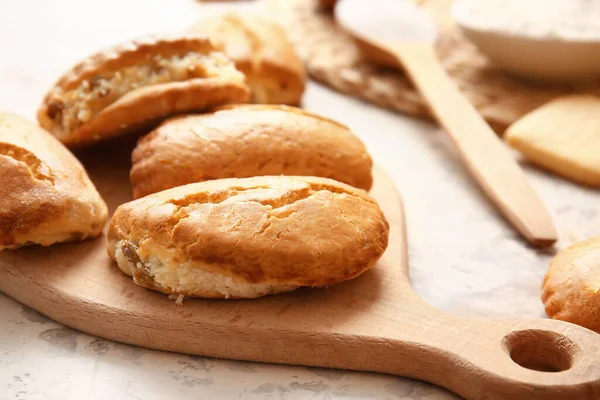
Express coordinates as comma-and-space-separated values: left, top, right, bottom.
335, 0, 557, 246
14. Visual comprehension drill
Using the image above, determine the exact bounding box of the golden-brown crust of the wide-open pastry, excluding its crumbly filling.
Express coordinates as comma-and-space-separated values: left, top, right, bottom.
37, 37, 249, 147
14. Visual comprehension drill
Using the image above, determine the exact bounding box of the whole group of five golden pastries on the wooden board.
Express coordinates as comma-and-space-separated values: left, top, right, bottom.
0, 14, 389, 298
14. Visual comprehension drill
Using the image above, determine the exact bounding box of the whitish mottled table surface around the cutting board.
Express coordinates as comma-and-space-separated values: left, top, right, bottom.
0, 0, 600, 400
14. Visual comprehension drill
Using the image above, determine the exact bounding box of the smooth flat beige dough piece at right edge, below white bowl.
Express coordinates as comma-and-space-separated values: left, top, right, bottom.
505, 95, 600, 187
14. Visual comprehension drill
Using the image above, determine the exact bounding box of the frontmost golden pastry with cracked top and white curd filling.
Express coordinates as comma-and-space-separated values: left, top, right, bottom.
108, 176, 389, 298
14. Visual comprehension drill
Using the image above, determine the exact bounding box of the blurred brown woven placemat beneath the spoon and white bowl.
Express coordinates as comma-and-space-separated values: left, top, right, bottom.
264, 0, 600, 133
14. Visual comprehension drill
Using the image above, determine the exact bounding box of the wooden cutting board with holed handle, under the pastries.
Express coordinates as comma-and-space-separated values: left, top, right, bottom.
0, 141, 600, 400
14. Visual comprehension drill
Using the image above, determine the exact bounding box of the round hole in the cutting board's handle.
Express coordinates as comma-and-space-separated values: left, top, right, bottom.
503, 329, 579, 372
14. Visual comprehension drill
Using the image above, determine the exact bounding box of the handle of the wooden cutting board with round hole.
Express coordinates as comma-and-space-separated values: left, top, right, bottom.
370, 305, 600, 400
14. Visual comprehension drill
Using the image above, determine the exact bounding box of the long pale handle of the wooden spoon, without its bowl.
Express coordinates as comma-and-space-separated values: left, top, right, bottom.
390, 44, 557, 246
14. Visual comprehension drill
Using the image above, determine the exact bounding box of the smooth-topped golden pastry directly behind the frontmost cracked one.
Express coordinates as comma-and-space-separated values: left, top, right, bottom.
130, 105, 373, 198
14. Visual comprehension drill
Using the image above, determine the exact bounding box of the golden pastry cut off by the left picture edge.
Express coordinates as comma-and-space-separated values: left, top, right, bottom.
0, 113, 108, 250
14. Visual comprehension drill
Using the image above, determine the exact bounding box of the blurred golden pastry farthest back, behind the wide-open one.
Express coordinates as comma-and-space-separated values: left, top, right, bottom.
188, 14, 306, 105
